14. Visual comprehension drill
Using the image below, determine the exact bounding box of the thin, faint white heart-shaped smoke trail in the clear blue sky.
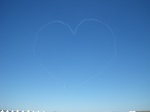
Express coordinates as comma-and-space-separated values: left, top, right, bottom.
33, 19, 116, 87
